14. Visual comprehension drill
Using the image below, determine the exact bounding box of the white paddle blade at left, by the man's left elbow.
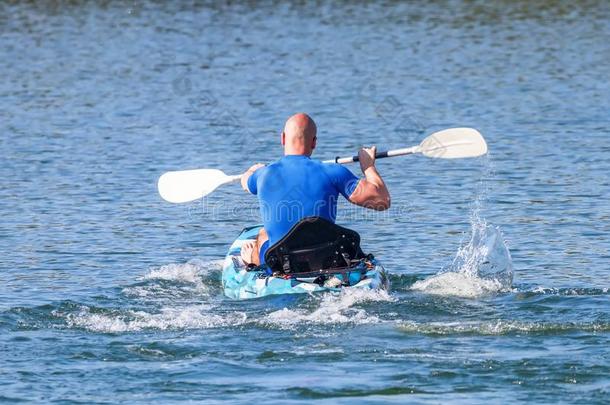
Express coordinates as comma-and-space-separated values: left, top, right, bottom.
157, 169, 240, 204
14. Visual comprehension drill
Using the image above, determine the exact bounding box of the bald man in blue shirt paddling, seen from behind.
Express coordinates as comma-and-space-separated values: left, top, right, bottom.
241, 113, 390, 265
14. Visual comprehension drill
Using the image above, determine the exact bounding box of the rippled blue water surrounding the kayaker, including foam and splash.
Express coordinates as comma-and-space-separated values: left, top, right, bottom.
0, 1, 610, 403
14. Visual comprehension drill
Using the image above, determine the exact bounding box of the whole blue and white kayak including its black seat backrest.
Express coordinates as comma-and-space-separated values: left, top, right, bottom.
222, 217, 388, 299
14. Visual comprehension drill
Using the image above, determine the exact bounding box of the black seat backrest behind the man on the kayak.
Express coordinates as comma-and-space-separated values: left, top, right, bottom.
265, 217, 364, 274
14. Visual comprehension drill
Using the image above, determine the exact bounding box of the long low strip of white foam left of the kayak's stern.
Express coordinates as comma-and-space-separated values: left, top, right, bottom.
66, 305, 247, 333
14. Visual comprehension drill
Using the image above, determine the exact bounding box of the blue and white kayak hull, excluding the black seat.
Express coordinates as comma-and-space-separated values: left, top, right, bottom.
222, 225, 388, 299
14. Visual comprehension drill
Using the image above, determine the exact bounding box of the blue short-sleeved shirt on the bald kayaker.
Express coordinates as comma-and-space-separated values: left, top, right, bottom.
248, 155, 358, 245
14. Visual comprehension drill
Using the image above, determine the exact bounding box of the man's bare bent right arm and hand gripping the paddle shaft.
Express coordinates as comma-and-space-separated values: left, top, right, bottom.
349, 146, 391, 211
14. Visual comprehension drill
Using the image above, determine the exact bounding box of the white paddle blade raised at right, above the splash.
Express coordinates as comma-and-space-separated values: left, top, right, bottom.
419, 128, 487, 159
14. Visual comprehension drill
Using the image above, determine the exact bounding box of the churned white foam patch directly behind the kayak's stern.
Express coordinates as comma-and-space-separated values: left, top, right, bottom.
262, 290, 395, 328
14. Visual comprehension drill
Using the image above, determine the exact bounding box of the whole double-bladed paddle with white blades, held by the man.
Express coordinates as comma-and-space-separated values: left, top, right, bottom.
157, 128, 487, 203
